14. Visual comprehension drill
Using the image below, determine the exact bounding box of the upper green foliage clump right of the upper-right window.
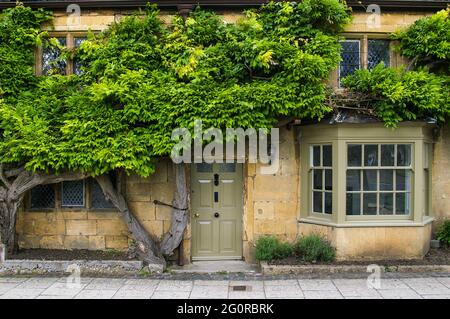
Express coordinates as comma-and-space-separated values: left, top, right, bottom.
393, 8, 450, 72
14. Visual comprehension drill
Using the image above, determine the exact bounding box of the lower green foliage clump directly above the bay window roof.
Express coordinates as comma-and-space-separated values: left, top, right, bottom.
343, 63, 450, 127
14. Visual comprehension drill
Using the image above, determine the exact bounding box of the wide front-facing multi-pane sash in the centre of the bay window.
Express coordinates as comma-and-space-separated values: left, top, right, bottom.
346, 144, 412, 215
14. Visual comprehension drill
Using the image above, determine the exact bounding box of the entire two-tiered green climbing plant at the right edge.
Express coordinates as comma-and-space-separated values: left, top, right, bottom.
343, 9, 450, 127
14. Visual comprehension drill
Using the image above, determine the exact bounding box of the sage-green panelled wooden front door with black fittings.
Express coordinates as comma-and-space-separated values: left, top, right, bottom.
191, 163, 243, 260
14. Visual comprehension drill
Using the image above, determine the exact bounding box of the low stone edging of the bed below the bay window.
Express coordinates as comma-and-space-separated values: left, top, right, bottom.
260, 262, 450, 276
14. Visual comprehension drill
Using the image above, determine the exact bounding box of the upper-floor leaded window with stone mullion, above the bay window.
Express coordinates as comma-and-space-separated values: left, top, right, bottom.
338, 37, 391, 85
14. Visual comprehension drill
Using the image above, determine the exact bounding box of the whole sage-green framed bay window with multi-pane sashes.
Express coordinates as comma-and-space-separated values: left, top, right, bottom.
299, 122, 433, 225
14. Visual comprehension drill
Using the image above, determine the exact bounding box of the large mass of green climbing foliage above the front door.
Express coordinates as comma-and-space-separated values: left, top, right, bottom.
0, 0, 350, 176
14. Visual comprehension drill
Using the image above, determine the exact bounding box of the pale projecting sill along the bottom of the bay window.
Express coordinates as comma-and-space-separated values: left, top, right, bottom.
298, 216, 434, 228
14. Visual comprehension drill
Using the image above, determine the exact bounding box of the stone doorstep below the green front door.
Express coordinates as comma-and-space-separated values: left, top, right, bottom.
171, 260, 259, 274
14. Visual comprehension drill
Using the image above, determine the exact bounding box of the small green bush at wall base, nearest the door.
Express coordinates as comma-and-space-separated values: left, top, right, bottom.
255, 236, 293, 261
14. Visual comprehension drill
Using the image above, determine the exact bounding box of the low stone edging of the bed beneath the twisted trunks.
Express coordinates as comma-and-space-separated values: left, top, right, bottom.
0, 259, 148, 275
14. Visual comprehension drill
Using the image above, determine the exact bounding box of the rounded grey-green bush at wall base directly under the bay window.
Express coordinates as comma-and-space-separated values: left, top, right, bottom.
294, 234, 335, 263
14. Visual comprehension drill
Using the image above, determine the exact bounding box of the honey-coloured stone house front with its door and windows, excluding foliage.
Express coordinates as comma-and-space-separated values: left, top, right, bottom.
0, 0, 450, 264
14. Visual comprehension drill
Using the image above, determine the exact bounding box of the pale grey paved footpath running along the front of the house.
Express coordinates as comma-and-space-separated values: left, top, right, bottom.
0, 275, 450, 299
